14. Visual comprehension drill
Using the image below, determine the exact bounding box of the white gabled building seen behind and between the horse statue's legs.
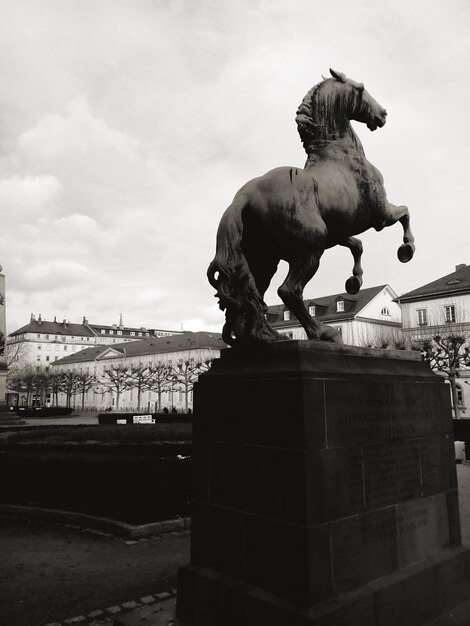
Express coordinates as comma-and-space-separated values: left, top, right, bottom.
267, 285, 402, 348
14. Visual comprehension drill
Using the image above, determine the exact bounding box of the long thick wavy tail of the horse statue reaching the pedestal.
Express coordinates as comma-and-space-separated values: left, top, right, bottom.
207, 197, 267, 346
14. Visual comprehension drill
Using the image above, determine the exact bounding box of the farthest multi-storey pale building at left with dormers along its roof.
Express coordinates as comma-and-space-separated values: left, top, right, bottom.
7, 312, 182, 371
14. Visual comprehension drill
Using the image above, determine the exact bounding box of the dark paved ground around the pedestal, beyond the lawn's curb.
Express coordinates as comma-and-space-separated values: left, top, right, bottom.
0, 465, 470, 626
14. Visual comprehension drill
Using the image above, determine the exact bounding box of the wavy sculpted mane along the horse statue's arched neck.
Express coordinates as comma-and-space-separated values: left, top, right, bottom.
295, 78, 356, 155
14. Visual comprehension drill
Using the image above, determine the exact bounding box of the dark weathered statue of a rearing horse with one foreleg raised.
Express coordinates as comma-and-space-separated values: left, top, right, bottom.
207, 69, 415, 346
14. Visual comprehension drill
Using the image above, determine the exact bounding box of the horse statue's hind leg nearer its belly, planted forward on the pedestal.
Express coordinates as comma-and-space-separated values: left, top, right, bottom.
277, 253, 342, 343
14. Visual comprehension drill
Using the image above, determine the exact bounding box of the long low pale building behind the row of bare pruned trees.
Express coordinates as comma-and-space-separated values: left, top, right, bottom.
49, 332, 227, 412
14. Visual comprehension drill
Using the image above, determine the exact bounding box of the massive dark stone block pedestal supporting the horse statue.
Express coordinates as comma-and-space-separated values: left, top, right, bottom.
177, 341, 470, 626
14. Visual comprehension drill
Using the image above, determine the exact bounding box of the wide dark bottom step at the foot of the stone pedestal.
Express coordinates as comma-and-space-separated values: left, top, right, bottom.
176, 546, 470, 626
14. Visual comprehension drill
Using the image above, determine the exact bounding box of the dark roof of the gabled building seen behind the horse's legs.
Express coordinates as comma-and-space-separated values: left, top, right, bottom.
268, 285, 393, 328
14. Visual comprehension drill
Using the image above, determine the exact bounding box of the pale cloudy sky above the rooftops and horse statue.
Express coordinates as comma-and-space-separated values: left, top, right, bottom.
0, 0, 470, 332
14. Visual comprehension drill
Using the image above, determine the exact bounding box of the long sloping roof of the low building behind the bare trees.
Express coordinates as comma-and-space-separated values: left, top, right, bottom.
52, 331, 228, 365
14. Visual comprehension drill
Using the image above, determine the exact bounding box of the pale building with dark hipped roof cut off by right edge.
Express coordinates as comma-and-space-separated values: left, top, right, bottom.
396, 263, 470, 418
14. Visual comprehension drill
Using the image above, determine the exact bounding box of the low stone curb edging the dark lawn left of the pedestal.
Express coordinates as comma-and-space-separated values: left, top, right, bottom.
0, 504, 191, 539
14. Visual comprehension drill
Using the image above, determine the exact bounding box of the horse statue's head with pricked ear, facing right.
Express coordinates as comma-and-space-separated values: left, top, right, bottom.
330, 69, 387, 130
